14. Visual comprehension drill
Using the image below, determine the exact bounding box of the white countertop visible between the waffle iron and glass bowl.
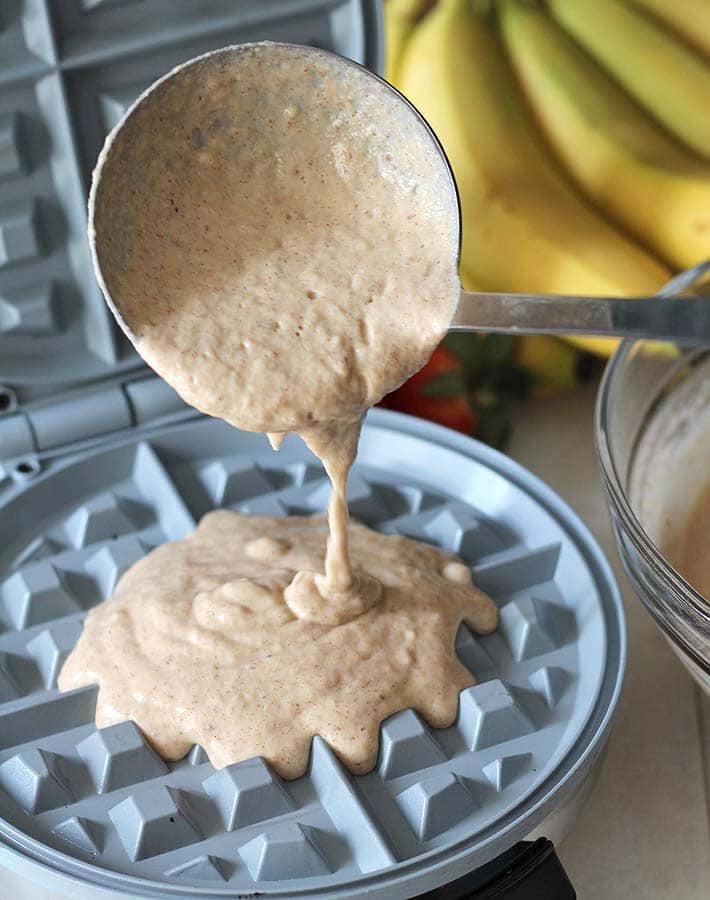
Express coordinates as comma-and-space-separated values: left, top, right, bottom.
508, 385, 710, 900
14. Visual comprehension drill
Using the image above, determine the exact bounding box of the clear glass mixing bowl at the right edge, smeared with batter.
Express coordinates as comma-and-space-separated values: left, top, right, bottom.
595, 338, 710, 693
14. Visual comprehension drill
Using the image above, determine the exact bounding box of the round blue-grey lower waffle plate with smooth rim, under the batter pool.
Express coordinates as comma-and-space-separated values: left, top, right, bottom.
0, 411, 624, 897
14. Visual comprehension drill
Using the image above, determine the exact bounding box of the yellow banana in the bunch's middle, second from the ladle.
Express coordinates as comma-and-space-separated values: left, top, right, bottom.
499, 0, 710, 269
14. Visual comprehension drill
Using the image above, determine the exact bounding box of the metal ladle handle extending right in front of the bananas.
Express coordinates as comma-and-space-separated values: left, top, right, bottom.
450, 291, 710, 343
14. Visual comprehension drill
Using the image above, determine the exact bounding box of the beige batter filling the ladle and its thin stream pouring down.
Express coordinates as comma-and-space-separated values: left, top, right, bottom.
92, 44, 460, 609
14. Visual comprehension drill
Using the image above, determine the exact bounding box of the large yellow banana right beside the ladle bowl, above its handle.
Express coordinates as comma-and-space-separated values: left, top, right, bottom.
400, 0, 669, 354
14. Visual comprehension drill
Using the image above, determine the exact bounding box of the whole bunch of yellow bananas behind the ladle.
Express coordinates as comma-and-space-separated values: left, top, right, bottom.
385, 0, 710, 369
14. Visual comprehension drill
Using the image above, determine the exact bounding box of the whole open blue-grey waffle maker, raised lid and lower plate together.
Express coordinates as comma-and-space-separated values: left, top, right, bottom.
0, 0, 625, 900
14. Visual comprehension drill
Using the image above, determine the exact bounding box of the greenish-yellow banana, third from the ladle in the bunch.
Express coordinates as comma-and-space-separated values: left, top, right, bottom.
548, 0, 710, 158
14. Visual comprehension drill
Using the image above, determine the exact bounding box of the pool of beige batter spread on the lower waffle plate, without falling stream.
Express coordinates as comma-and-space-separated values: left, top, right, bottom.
60, 510, 496, 778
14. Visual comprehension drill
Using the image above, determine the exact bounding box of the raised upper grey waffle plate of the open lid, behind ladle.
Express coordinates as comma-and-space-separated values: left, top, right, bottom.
0, 0, 379, 403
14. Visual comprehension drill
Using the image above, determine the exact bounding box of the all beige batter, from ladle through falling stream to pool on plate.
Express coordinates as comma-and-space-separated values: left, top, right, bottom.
59, 45, 496, 777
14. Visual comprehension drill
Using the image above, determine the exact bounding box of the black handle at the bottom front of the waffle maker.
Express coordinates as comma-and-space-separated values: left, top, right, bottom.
421, 838, 577, 900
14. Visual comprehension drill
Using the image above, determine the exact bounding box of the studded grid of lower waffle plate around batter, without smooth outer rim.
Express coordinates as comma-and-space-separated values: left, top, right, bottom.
0, 428, 608, 891
